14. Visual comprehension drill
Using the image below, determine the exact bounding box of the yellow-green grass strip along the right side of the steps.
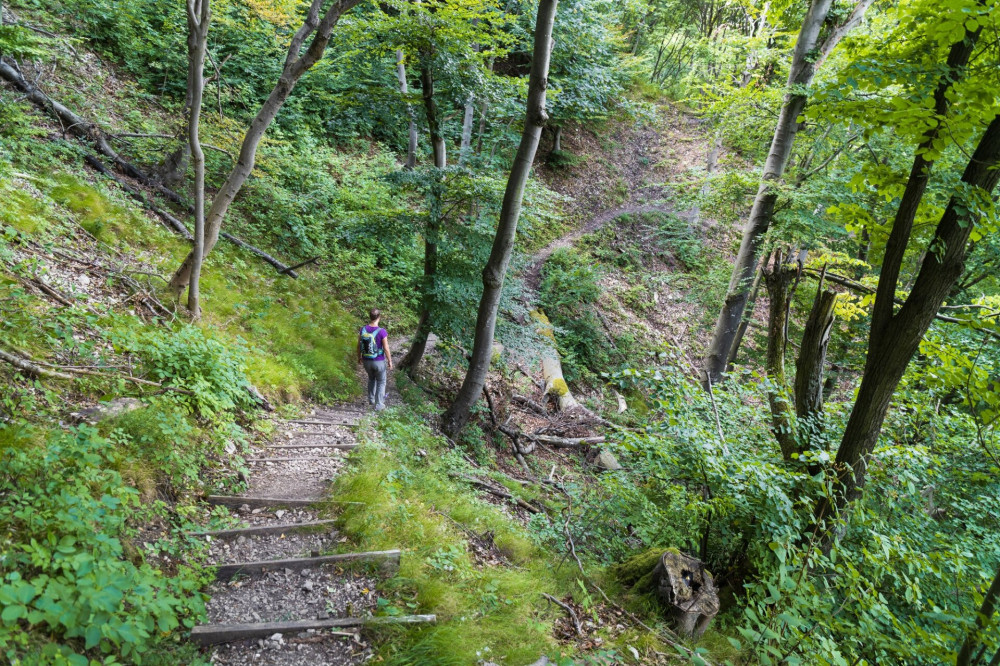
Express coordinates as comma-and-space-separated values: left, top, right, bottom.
334, 409, 572, 664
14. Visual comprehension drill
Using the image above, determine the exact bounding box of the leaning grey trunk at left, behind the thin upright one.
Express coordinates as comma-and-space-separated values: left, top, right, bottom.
170, 0, 361, 294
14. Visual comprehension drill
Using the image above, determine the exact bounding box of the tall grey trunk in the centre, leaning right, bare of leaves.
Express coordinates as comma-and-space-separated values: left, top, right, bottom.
442, 0, 558, 435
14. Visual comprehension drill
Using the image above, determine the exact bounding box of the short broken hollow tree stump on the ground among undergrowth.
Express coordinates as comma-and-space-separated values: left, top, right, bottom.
653, 550, 719, 638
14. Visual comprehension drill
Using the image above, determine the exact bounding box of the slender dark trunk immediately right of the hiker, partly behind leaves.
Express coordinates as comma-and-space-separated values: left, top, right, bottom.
400, 60, 448, 372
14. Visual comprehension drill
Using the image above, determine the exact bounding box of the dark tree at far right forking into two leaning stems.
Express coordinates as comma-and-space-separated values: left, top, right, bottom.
816, 41, 1000, 518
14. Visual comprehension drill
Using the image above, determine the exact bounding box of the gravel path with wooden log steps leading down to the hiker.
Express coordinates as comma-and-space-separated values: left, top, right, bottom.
191, 386, 433, 666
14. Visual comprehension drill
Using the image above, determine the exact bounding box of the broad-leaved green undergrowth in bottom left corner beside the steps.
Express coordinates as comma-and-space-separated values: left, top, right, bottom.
0, 426, 204, 664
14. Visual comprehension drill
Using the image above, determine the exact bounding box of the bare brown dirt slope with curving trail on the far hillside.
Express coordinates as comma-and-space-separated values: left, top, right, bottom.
524, 107, 709, 294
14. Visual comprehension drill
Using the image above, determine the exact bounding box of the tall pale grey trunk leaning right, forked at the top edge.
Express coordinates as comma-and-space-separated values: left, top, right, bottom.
704, 0, 871, 389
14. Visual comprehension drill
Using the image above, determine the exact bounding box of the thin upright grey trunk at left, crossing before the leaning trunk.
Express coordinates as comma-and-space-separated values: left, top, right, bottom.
187, 0, 212, 321
